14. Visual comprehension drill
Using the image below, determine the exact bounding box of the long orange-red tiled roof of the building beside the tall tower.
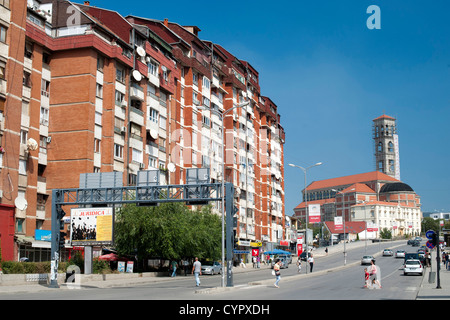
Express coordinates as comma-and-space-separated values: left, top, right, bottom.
308, 171, 400, 191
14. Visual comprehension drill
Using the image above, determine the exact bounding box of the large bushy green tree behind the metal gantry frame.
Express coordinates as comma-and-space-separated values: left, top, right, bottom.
114, 203, 221, 268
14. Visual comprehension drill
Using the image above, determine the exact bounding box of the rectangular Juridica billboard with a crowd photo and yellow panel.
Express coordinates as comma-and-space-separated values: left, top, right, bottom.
70, 208, 113, 245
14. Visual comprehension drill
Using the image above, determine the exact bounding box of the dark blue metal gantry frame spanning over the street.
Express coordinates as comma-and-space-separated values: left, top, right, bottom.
49, 182, 236, 288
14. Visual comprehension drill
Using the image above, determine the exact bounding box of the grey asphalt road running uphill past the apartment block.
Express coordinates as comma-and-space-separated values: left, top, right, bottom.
0, 242, 422, 301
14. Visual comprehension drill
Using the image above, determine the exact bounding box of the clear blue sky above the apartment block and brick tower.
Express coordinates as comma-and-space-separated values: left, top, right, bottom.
89, 0, 450, 215
